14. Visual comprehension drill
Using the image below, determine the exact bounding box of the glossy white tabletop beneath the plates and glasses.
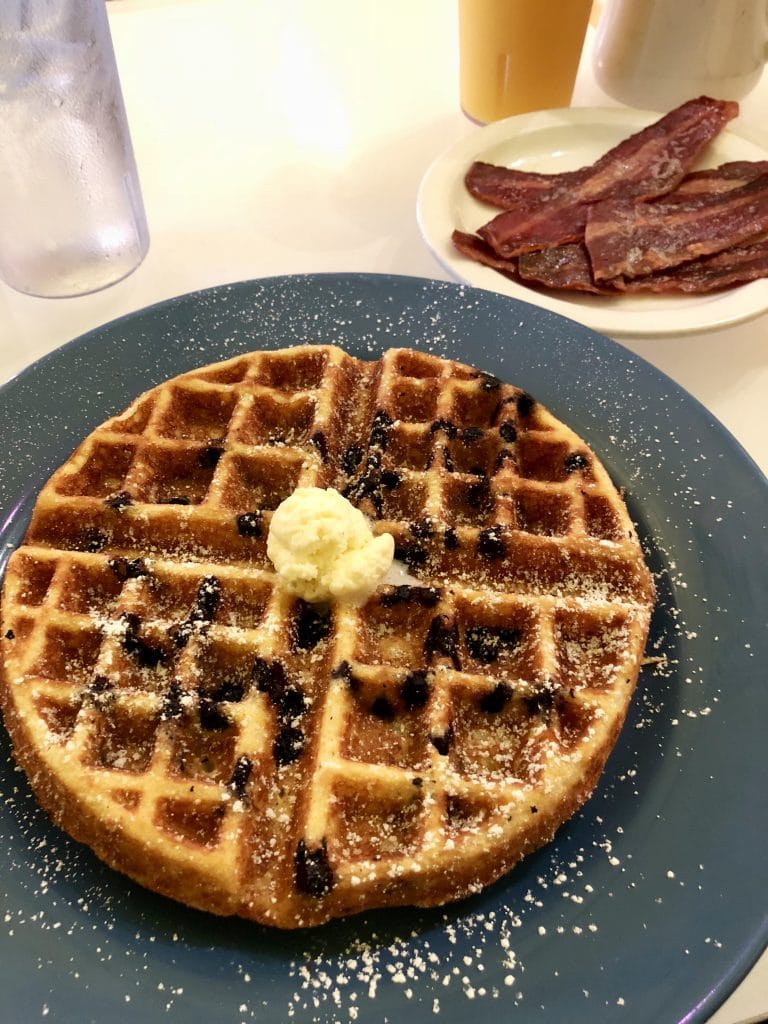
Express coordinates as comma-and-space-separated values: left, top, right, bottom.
0, 0, 768, 1024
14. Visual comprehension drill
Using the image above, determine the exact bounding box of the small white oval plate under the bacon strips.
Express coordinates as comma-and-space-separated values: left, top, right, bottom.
417, 108, 768, 338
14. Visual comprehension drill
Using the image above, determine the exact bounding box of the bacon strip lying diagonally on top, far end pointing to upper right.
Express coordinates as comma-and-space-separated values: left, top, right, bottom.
475, 96, 738, 257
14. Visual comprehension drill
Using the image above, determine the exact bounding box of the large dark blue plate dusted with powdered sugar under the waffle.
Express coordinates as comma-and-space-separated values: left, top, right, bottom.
0, 274, 768, 1024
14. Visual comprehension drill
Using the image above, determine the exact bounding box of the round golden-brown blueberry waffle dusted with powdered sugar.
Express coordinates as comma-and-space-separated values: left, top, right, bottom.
0, 345, 653, 928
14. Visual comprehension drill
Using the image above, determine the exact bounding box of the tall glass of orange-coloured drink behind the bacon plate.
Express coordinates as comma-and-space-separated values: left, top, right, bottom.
459, 0, 592, 124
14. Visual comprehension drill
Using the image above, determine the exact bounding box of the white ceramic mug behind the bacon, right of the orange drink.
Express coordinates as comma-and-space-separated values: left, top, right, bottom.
594, 0, 768, 111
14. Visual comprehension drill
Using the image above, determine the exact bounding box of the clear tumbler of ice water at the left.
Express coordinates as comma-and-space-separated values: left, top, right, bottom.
0, 0, 150, 297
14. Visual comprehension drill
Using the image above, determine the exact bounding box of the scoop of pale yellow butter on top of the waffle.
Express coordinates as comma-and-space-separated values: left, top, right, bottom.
266, 487, 394, 601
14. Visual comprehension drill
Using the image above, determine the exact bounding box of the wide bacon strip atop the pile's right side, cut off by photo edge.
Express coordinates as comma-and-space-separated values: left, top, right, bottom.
585, 174, 768, 282
